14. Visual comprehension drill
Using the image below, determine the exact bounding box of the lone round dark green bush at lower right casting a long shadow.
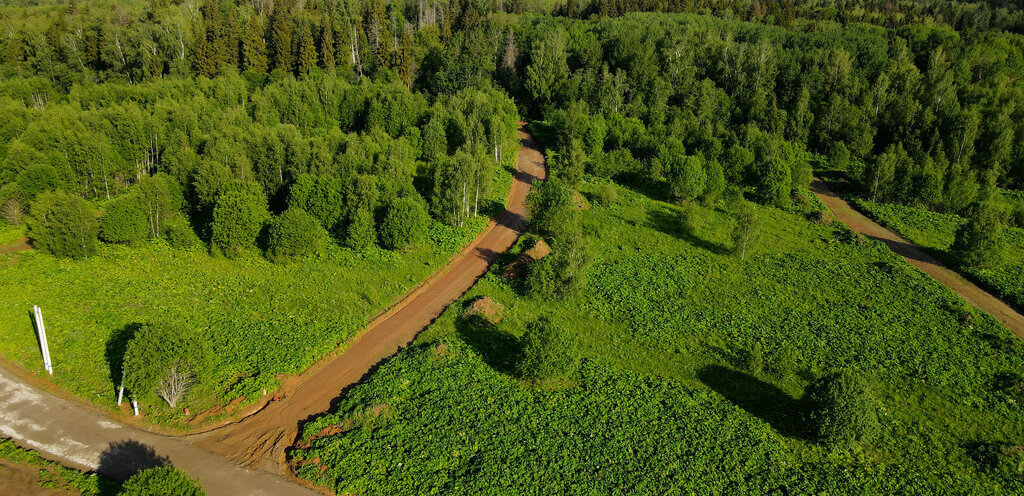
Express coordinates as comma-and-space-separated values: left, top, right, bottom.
808, 370, 880, 445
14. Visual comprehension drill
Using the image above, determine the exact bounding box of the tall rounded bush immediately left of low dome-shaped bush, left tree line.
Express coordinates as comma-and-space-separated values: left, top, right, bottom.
211, 191, 269, 255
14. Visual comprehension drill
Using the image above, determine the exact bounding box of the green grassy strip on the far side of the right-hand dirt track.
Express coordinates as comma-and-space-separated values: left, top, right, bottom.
855, 199, 1024, 308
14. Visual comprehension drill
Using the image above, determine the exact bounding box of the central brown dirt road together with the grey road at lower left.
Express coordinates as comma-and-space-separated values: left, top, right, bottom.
0, 123, 547, 496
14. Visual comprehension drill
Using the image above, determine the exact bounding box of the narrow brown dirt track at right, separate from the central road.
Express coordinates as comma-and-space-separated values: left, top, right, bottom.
811, 177, 1024, 339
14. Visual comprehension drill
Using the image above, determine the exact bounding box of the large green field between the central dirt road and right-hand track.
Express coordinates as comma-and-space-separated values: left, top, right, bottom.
291, 180, 1024, 495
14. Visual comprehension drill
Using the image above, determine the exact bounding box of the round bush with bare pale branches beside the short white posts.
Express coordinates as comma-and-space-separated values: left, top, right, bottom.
123, 324, 211, 407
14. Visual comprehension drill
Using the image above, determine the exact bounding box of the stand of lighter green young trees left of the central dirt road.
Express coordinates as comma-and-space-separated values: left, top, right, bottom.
0, 71, 518, 258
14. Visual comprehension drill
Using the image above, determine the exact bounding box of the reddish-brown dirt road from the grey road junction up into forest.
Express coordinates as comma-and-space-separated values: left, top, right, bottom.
189, 124, 546, 472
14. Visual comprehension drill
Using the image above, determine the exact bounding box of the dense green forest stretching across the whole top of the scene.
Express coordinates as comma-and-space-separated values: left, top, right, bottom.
0, 1, 1024, 259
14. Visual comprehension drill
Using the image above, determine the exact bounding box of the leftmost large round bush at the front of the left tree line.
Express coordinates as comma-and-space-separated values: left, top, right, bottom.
29, 191, 97, 258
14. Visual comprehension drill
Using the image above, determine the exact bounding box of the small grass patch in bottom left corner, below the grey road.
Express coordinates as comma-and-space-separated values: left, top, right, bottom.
0, 439, 121, 496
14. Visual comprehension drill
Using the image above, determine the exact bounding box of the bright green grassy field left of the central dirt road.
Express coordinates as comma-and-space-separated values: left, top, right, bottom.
0, 166, 511, 426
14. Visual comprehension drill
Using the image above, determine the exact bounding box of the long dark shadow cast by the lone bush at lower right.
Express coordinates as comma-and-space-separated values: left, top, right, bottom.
697, 365, 814, 440
